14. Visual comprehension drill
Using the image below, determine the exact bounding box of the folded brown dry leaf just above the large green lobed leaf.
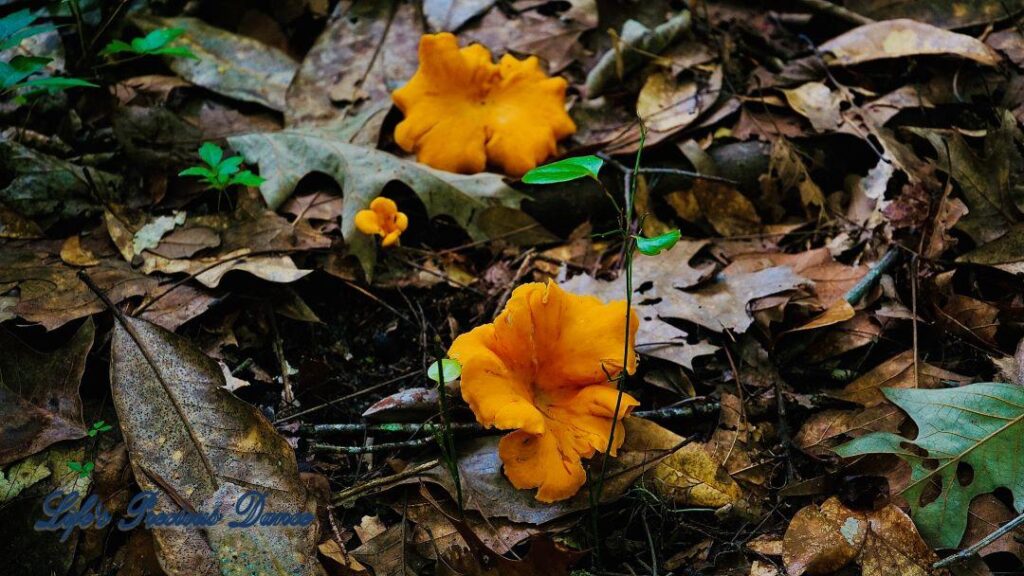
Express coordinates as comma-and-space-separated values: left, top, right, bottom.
825, 349, 970, 408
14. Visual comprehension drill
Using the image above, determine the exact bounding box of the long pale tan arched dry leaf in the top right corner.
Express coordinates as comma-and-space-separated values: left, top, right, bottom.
818, 18, 999, 66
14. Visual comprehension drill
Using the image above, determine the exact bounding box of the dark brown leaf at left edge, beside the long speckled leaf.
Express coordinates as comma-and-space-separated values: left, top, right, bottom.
0, 320, 94, 465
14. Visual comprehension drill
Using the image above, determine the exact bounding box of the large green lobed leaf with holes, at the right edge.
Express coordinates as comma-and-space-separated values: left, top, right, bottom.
836, 382, 1024, 548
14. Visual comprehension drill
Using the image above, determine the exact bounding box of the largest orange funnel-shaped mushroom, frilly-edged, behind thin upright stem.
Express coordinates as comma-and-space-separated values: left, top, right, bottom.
449, 282, 640, 502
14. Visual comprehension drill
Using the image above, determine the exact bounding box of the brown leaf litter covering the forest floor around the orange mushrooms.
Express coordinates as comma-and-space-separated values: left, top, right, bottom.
6, 0, 1024, 576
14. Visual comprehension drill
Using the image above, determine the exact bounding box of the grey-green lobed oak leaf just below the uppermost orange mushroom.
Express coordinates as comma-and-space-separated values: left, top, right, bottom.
228, 129, 522, 277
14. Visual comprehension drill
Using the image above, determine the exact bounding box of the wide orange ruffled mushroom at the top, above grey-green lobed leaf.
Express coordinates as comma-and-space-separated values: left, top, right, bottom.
391, 32, 575, 176
